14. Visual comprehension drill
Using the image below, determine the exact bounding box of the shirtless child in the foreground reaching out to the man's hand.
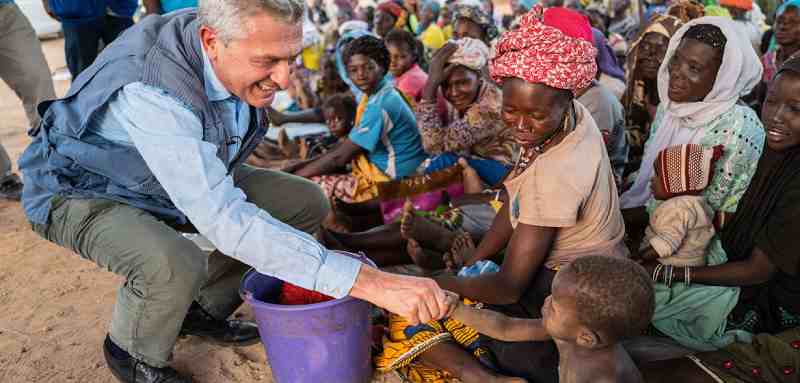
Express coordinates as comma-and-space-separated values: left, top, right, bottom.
450, 255, 655, 383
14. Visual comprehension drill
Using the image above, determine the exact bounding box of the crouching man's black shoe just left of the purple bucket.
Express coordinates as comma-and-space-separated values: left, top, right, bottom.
180, 302, 259, 346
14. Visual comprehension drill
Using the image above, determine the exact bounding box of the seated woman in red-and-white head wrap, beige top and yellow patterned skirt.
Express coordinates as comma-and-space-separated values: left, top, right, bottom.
377, 6, 627, 382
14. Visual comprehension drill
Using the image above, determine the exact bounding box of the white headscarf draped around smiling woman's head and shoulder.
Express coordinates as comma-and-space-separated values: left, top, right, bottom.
620, 16, 764, 209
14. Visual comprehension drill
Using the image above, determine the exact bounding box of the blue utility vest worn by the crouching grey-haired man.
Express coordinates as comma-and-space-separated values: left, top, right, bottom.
19, 9, 267, 224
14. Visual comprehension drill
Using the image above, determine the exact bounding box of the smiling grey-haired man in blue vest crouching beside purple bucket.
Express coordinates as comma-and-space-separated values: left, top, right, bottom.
19, 0, 448, 383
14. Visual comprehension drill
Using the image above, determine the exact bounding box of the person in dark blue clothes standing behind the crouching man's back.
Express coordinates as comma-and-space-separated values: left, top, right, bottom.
42, 0, 139, 79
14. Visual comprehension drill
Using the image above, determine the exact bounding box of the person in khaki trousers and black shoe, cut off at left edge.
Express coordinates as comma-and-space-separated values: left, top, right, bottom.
0, 0, 56, 201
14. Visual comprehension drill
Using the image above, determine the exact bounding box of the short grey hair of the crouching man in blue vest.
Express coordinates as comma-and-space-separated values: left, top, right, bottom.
197, 0, 305, 43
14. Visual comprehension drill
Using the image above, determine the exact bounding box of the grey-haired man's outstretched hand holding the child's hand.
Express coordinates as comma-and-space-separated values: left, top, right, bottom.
350, 265, 450, 326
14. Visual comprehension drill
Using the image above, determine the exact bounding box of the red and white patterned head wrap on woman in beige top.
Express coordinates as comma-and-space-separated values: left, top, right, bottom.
490, 5, 597, 93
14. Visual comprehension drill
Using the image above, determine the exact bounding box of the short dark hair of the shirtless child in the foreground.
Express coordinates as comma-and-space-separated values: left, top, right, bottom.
560, 255, 655, 340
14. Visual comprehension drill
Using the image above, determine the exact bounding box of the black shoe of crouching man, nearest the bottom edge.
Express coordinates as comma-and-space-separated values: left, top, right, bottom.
103, 337, 192, 383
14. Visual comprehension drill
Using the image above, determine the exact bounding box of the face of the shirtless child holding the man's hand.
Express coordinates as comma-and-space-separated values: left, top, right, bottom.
542, 272, 582, 342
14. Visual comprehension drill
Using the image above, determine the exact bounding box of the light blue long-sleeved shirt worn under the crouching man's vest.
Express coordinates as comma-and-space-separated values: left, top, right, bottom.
87, 48, 361, 298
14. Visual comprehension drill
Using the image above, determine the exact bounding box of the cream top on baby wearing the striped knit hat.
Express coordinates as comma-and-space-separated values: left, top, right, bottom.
642, 196, 715, 267
